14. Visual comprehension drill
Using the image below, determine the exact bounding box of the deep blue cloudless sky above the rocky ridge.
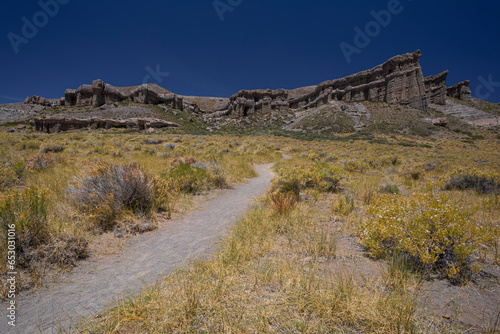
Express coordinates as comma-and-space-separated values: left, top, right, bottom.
0, 0, 500, 103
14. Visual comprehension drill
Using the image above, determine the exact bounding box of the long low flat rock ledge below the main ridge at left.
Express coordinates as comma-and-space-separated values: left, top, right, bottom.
30, 116, 179, 133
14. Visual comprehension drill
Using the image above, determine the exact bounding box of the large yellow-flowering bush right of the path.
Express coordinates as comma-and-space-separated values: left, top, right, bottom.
360, 192, 488, 282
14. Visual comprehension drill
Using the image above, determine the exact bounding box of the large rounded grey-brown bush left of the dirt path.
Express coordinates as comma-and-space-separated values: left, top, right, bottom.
67, 162, 155, 230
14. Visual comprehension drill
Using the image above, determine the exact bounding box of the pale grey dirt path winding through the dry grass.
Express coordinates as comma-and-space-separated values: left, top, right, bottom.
0, 165, 273, 333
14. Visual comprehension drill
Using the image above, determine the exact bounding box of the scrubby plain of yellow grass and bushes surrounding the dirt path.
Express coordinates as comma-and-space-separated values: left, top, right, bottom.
0, 109, 500, 333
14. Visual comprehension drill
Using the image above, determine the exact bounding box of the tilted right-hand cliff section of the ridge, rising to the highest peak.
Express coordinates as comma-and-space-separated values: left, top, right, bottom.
215, 50, 460, 118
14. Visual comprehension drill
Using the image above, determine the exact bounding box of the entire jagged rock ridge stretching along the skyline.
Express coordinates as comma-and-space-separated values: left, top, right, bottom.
21, 50, 471, 118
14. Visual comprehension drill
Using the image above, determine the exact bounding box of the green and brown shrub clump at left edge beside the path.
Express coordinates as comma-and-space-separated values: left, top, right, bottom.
0, 187, 88, 298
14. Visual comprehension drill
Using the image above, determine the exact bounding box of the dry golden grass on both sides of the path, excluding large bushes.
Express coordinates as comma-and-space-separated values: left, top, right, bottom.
0, 125, 500, 333
